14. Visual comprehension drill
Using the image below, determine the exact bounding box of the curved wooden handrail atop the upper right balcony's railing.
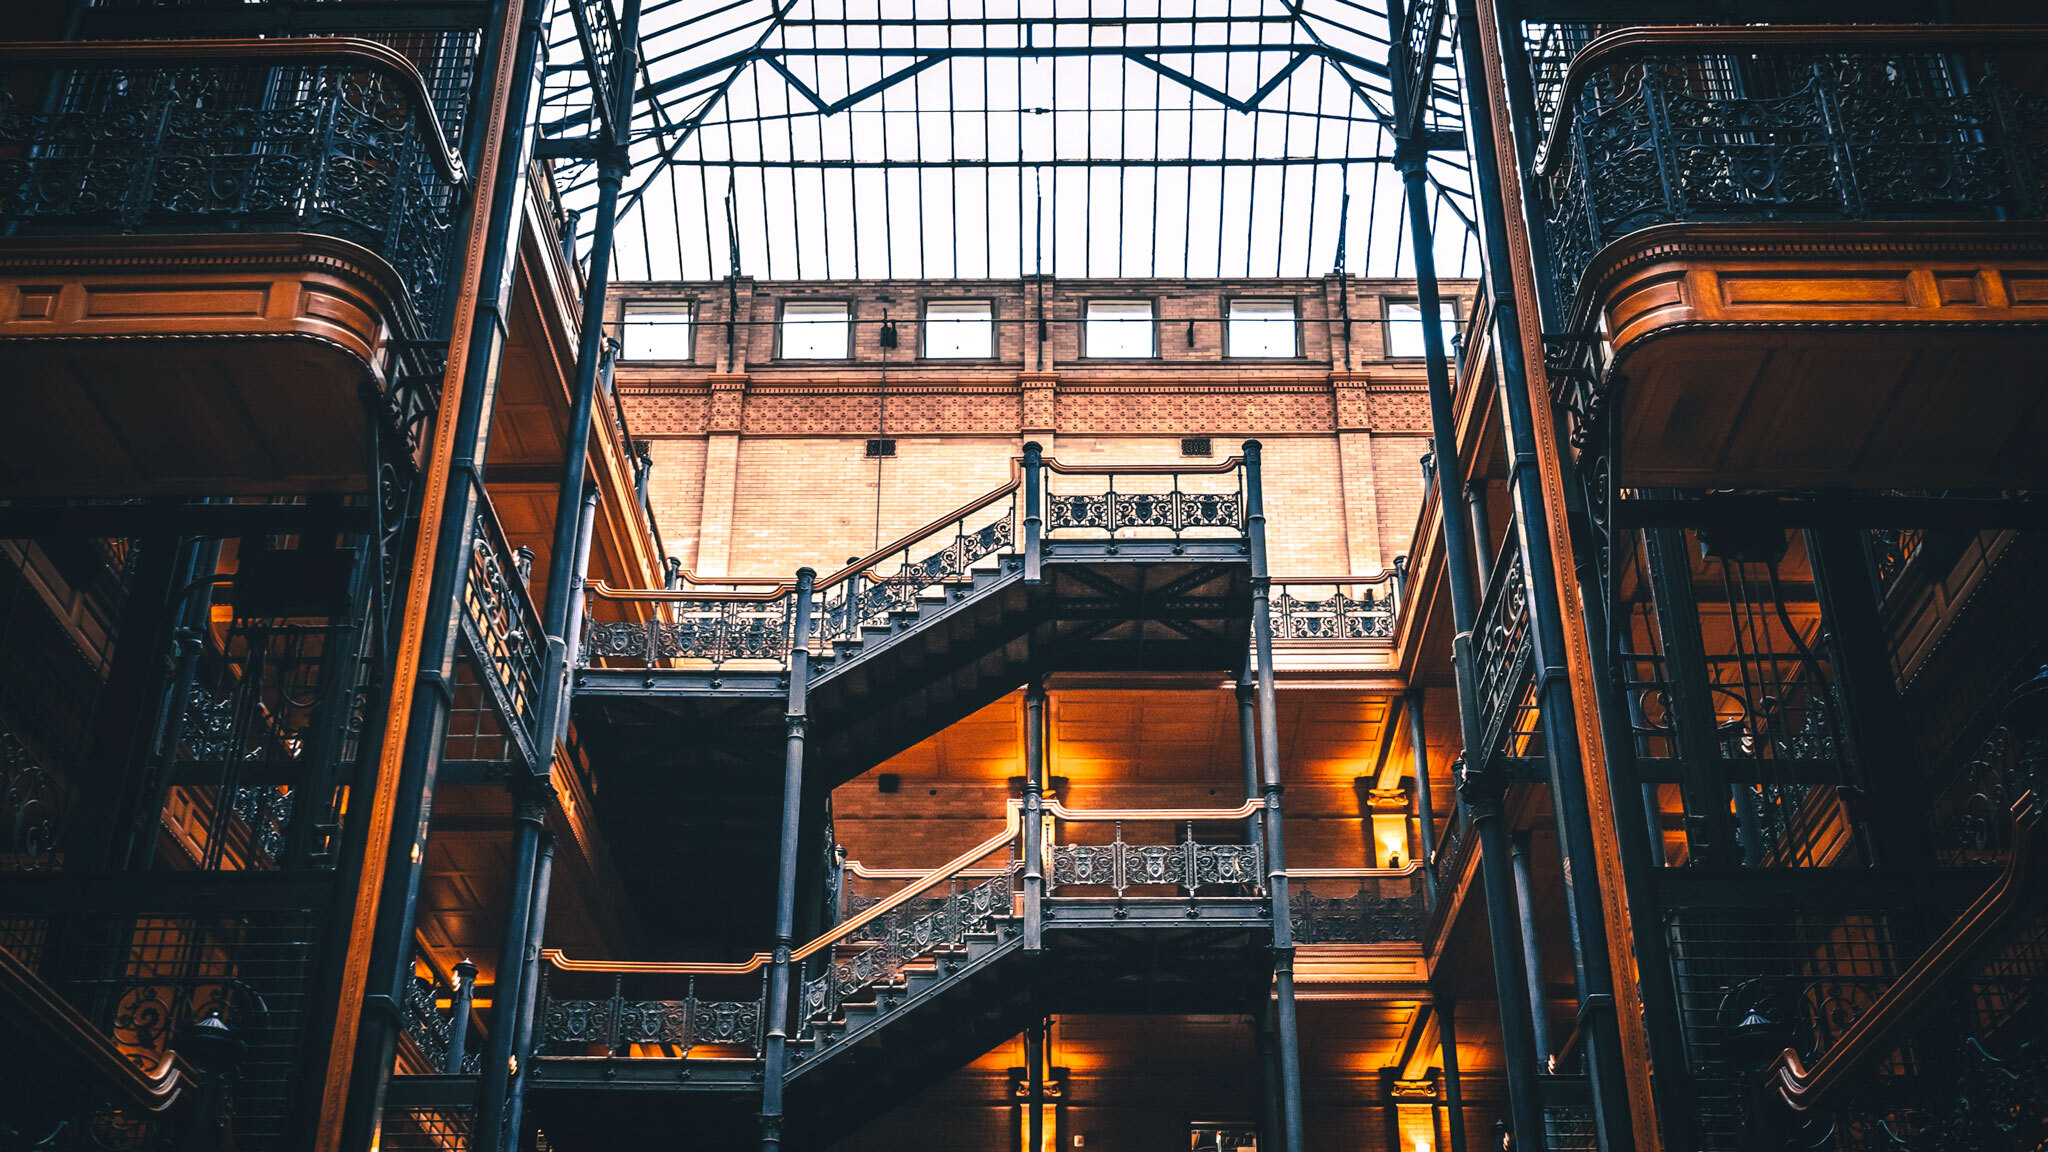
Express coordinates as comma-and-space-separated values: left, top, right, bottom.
1536, 25, 2048, 176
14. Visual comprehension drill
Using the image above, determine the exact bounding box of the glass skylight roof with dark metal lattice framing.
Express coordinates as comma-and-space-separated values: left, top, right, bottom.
543, 0, 1475, 281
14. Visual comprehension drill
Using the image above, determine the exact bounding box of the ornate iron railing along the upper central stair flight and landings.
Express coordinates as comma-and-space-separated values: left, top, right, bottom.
578, 446, 1253, 668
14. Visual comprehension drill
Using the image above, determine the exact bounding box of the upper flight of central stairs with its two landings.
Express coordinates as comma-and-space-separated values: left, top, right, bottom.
573, 455, 1255, 955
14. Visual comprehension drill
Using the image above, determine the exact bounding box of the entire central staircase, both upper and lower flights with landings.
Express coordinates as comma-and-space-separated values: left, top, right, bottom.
528, 447, 1272, 1152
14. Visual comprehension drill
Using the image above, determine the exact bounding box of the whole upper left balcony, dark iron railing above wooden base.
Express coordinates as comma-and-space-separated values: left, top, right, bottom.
0, 39, 465, 496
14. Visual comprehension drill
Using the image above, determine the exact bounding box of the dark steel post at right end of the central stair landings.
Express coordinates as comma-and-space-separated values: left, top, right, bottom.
1245, 441, 1303, 1152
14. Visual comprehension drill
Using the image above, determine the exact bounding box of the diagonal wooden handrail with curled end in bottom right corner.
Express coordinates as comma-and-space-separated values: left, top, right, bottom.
1765, 791, 2042, 1111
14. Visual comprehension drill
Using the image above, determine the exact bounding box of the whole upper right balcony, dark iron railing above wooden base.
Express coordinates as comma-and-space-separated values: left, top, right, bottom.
1538, 25, 2048, 488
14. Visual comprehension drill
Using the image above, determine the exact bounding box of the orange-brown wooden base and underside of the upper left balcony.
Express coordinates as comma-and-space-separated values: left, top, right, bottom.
0, 234, 406, 498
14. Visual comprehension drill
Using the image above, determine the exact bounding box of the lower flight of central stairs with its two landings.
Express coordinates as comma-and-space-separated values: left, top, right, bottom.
528, 804, 1272, 1152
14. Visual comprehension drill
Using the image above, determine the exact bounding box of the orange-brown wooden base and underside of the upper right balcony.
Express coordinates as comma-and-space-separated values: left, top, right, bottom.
1585, 221, 2048, 488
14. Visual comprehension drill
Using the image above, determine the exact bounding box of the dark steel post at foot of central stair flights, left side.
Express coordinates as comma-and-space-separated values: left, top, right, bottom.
760, 568, 817, 1152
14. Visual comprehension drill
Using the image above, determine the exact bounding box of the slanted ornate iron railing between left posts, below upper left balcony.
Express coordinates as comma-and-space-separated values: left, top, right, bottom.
463, 500, 553, 771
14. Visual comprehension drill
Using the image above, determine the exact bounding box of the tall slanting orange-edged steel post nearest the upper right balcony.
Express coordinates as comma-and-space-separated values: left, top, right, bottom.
1458, 0, 1636, 1131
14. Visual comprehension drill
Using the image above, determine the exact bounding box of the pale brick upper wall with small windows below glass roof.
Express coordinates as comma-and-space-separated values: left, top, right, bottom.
612, 270, 1458, 576
